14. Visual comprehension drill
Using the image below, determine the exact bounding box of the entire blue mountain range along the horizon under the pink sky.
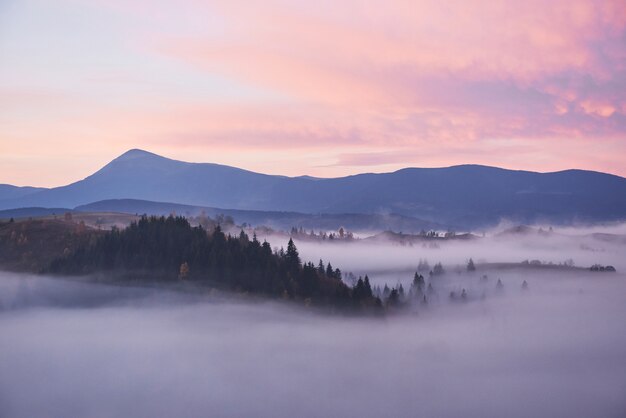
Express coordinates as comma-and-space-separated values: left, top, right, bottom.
0, 150, 626, 228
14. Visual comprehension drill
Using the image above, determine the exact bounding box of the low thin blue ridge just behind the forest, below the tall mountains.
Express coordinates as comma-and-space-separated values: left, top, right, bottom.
74, 199, 447, 232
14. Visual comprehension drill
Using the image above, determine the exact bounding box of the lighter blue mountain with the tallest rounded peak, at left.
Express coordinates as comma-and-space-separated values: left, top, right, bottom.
0, 150, 292, 209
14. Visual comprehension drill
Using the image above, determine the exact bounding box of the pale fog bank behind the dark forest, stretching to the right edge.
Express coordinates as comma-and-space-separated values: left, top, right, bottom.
288, 224, 626, 286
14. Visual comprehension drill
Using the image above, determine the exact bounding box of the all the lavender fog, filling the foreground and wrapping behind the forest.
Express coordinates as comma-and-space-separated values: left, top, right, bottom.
0, 227, 626, 418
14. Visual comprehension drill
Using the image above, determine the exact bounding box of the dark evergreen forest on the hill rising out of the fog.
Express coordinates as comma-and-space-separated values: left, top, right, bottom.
48, 216, 382, 312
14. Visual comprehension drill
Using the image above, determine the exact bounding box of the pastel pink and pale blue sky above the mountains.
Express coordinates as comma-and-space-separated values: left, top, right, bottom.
0, 0, 626, 186
